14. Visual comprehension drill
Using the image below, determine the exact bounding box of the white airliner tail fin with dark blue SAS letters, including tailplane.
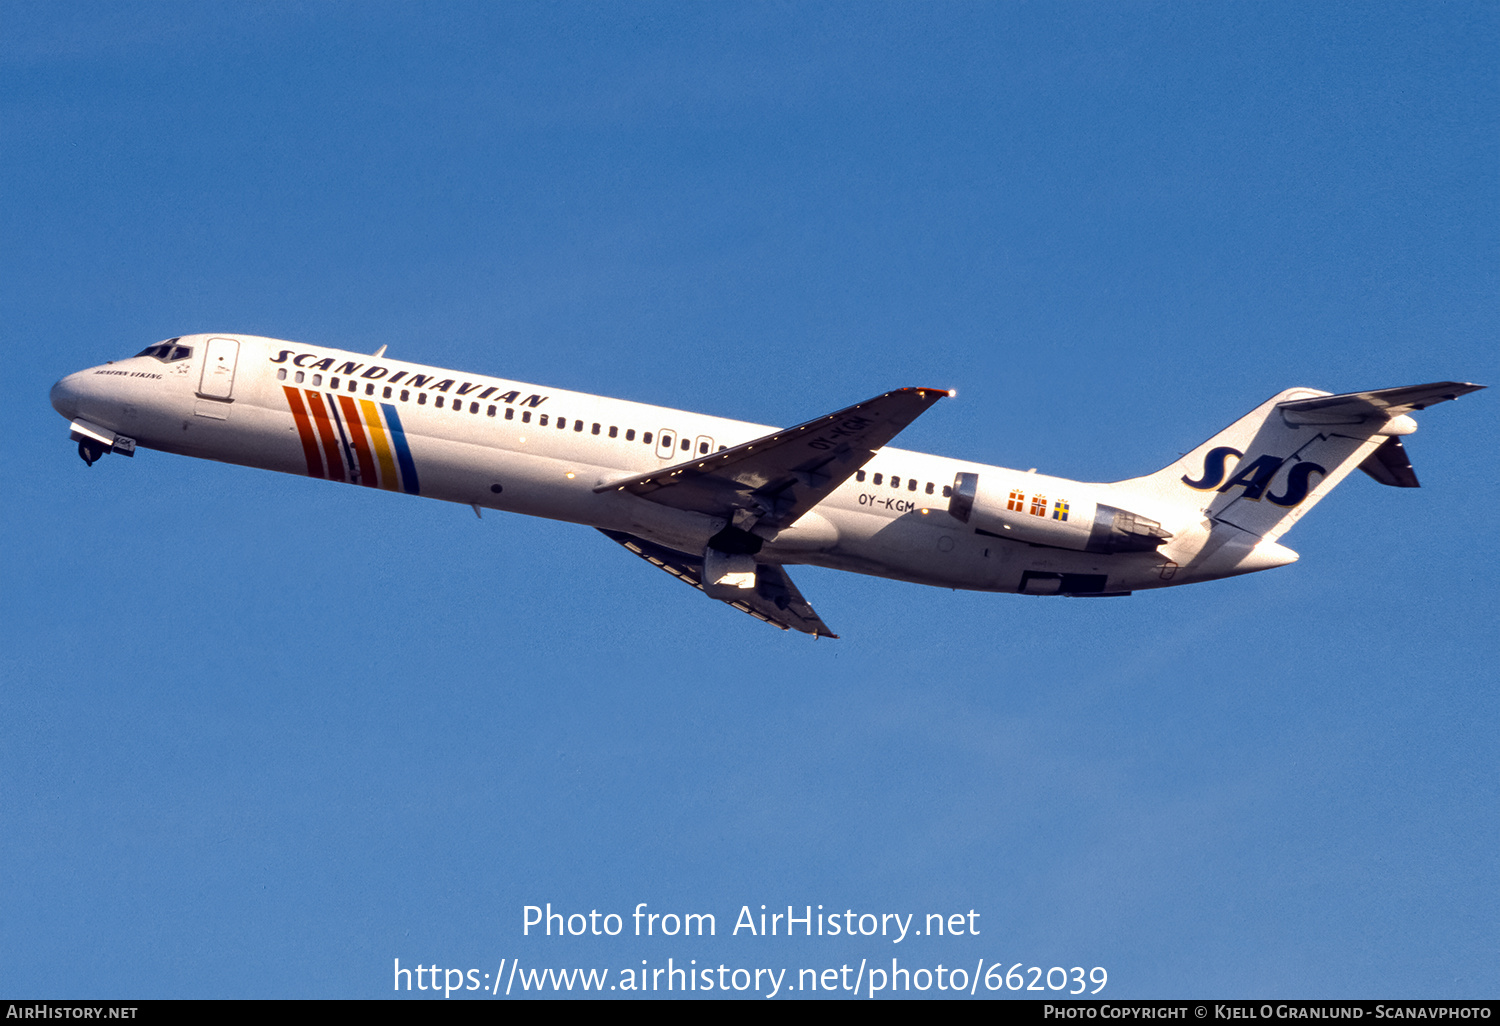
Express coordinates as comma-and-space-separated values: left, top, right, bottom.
1115, 381, 1484, 542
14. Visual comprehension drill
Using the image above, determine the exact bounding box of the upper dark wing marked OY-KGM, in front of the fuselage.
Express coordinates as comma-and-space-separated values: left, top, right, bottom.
594, 389, 950, 528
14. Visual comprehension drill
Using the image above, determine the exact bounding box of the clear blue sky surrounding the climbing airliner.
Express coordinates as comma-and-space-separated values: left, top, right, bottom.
0, 2, 1500, 998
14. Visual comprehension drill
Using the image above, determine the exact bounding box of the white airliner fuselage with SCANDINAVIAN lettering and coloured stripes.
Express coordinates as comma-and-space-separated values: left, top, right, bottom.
53, 335, 1242, 593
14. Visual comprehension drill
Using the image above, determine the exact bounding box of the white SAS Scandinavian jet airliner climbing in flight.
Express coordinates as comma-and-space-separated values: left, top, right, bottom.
51, 333, 1484, 638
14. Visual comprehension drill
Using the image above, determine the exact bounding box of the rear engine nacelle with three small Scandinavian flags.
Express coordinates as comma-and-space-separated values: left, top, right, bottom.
948, 474, 1172, 552
